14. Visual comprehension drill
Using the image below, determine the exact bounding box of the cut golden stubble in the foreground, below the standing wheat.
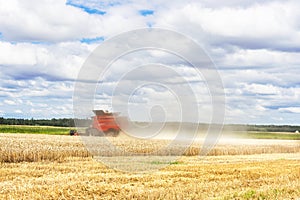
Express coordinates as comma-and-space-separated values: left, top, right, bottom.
0, 153, 300, 199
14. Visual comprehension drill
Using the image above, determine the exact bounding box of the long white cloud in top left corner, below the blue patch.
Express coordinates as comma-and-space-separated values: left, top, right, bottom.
0, 0, 152, 42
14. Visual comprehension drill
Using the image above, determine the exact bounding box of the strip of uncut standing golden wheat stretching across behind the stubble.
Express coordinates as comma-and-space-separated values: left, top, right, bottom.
0, 134, 300, 162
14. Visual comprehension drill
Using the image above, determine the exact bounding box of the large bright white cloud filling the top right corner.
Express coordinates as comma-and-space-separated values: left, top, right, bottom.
156, 1, 300, 49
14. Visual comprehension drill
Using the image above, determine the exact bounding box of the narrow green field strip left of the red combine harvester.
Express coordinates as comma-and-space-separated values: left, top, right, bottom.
0, 125, 72, 135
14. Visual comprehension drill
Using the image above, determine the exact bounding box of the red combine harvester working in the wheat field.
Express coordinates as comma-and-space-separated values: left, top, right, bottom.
85, 110, 120, 137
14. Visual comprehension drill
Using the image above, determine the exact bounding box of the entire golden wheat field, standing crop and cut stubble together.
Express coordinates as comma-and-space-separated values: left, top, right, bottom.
0, 134, 300, 199
